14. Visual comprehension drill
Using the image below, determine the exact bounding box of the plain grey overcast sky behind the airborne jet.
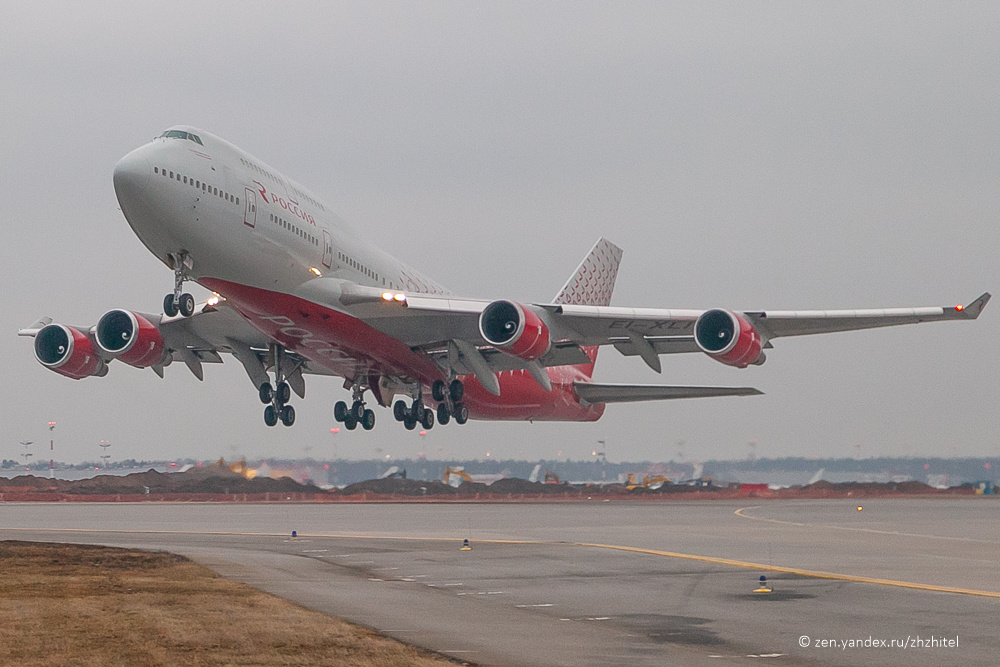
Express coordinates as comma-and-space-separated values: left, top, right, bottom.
0, 1, 1000, 468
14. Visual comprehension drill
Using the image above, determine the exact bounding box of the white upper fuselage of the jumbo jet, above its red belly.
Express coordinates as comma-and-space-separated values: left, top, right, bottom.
114, 126, 445, 302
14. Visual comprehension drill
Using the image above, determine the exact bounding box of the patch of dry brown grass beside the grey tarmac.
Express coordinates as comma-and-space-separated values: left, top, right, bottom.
0, 541, 455, 667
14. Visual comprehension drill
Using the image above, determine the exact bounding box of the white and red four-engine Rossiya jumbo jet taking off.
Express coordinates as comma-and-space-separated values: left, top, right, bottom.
18, 126, 990, 430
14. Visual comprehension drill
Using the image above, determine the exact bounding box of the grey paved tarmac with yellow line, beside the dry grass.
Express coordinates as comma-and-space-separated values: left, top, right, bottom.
0, 497, 1000, 665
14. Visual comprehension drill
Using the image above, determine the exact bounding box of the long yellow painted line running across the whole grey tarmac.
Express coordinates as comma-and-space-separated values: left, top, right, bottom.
7, 528, 1000, 599
